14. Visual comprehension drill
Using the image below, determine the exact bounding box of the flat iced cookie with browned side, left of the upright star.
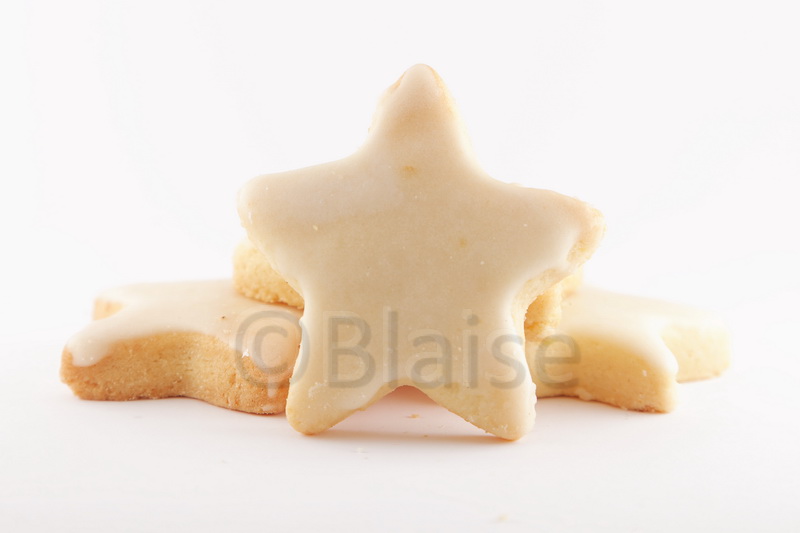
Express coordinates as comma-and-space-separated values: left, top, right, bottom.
61, 280, 300, 413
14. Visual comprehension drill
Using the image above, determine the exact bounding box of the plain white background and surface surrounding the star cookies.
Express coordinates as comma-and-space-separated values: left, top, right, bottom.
0, 0, 800, 531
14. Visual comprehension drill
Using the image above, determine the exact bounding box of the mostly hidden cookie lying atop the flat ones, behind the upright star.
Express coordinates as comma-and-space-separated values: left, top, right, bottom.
233, 239, 582, 339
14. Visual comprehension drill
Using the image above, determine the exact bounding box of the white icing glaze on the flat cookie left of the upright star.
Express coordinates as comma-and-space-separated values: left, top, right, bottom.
67, 280, 300, 368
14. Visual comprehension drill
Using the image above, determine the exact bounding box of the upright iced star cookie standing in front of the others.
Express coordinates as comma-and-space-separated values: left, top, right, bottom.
239, 65, 603, 439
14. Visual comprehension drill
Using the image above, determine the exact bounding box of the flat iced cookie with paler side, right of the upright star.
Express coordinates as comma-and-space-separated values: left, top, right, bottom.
526, 287, 730, 412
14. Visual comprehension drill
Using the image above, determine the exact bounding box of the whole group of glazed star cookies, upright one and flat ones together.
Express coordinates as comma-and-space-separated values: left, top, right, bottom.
62, 65, 728, 440
